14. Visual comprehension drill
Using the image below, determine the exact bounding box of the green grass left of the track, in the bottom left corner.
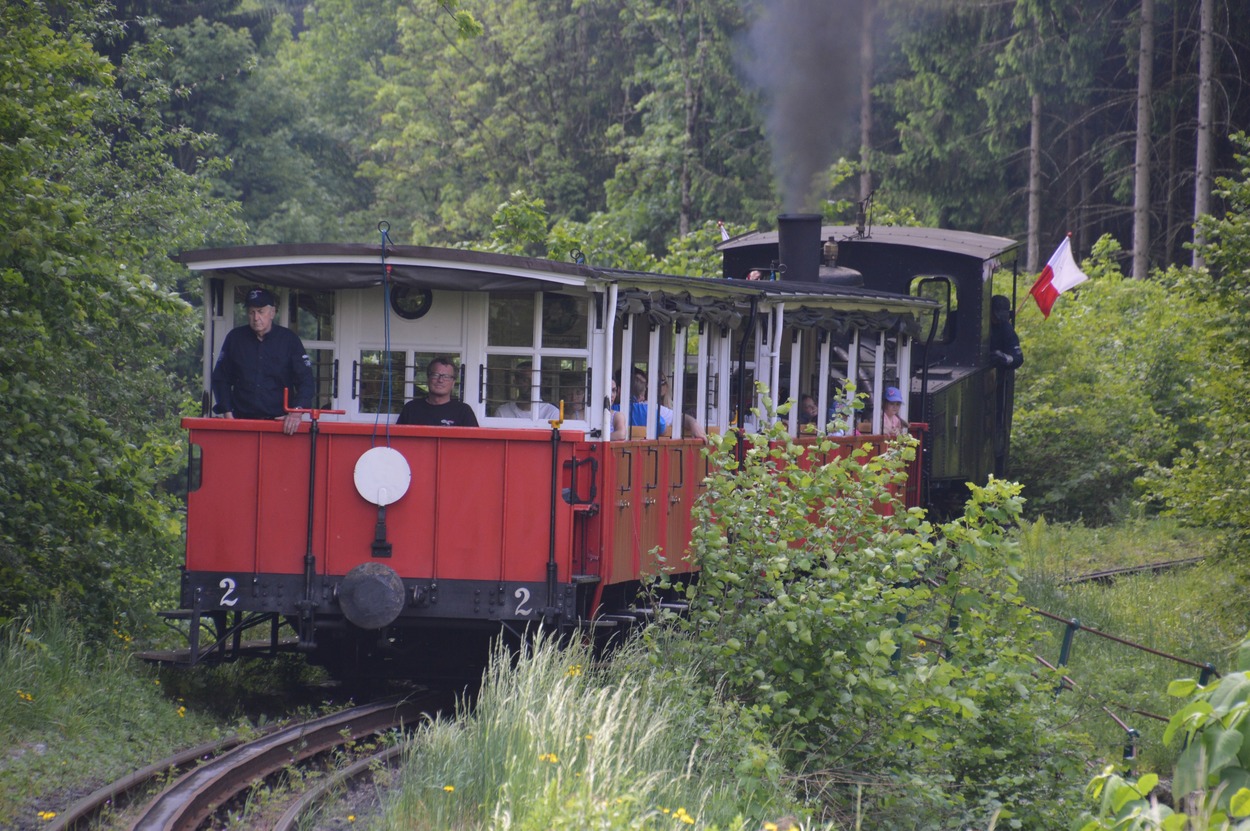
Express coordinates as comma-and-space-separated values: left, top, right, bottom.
0, 610, 230, 827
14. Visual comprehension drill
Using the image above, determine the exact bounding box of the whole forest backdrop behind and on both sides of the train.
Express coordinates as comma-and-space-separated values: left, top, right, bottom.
0, 0, 1250, 631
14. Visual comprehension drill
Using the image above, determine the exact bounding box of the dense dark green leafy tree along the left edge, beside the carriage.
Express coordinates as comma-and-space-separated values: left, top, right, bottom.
0, 0, 236, 629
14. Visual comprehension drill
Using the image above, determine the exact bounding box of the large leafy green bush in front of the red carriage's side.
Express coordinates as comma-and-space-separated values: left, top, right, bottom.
660, 430, 1080, 829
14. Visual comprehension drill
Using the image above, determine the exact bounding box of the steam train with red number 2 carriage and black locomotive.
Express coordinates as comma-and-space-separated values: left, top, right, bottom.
168, 215, 1018, 680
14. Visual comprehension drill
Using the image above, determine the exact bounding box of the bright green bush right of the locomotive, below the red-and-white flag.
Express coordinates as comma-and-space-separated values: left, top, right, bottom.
1011, 237, 1211, 524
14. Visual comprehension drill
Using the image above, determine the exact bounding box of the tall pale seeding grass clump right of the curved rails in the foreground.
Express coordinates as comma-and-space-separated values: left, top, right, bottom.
381, 629, 789, 831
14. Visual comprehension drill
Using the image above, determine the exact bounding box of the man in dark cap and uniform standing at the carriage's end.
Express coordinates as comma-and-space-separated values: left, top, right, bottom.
213, 289, 315, 436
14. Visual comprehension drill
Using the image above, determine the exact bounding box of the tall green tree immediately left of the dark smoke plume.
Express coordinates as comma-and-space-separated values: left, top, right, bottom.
604, 0, 776, 252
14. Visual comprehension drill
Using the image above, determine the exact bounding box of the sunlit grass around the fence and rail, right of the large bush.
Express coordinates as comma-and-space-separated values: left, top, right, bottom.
1020, 520, 1245, 772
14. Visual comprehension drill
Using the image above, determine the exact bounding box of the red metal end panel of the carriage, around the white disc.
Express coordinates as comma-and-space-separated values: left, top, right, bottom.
184, 419, 583, 581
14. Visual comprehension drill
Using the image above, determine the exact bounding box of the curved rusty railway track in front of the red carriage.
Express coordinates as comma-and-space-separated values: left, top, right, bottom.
48, 694, 450, 831
